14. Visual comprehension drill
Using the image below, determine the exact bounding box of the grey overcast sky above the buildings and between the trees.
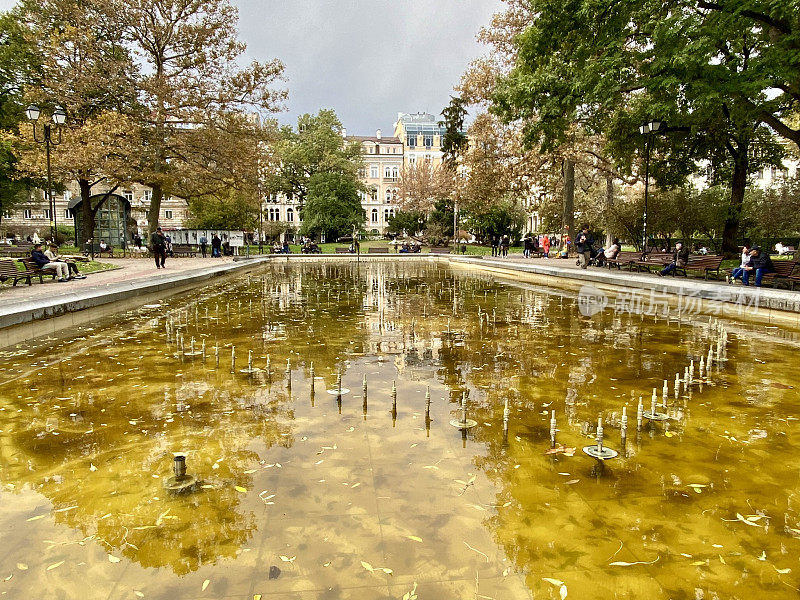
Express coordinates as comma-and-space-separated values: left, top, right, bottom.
0, 0, 502, 135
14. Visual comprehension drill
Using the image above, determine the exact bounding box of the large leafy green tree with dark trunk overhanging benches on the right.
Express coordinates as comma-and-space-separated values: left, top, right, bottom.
493, 0, 798, 252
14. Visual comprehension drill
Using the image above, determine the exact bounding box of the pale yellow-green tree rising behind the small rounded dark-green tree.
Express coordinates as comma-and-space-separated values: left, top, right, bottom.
266, 109, 363, 206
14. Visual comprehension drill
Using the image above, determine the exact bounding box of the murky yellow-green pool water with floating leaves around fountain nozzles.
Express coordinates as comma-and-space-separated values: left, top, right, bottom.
0, 263, 800, 600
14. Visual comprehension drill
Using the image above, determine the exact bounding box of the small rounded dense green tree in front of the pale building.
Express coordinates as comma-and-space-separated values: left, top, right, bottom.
300, 172, 366, 240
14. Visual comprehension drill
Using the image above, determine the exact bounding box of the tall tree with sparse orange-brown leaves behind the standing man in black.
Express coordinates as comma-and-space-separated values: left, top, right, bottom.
115, 0, 286, 232
